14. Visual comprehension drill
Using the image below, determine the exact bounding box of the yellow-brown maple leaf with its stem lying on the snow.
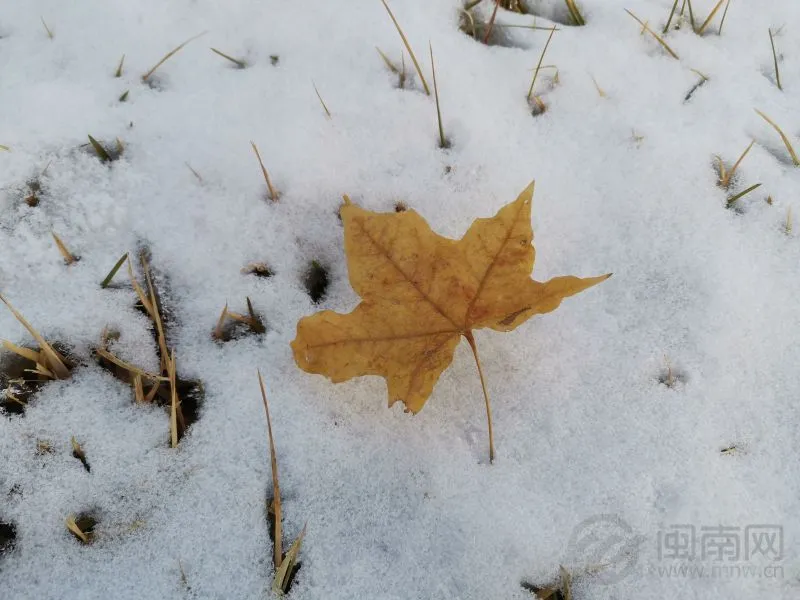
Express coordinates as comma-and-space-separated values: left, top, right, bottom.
292, 183, 610, 459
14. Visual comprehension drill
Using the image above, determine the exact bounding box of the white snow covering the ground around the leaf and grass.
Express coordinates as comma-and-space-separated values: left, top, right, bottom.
0, 0, 800, 600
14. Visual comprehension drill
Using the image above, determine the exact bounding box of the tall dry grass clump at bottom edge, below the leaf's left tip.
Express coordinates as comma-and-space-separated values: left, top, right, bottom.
257, 371, 306, 595
